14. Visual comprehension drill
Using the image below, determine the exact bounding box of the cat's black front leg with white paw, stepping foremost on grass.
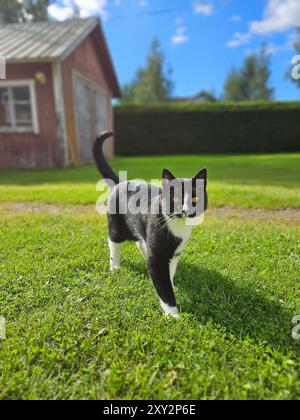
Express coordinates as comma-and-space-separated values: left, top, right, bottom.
148, 257, 179, 318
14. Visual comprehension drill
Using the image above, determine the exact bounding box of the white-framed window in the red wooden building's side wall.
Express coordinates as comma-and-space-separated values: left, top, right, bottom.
0, 82, 38, 133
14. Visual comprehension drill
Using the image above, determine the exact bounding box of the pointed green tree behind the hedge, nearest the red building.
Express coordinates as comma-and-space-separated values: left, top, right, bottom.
122, 39, 173, 105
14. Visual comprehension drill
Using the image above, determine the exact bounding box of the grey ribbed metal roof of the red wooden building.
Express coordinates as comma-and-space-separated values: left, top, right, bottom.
0, 18, 98, 62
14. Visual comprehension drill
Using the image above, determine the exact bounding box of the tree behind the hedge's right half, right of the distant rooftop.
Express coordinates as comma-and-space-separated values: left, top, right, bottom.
224, 45, 274, 101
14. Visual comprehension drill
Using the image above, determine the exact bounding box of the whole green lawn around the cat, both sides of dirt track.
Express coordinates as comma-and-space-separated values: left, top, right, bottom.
0, 155, 300, 399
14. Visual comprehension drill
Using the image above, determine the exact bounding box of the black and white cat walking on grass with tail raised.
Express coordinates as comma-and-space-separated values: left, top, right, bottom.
93, 132, 208, 318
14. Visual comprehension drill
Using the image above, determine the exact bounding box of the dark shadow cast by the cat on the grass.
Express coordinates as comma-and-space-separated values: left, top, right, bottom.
126, 261, 299, 353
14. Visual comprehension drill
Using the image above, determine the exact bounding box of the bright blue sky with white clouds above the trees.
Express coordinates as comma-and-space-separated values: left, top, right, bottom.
49, 0, 300, 100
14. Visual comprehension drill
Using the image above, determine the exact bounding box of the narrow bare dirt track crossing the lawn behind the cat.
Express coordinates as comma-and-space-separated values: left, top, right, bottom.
0, 203, 300, 225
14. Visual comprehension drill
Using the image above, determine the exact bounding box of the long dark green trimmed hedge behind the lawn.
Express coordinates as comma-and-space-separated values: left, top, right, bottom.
115, 102, 300, 156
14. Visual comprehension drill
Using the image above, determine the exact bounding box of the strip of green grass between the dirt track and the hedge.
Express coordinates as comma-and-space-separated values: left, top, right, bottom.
0, 154, 300, 209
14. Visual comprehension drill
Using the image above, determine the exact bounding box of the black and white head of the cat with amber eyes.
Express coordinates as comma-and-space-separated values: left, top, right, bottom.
162, 169, 208, 219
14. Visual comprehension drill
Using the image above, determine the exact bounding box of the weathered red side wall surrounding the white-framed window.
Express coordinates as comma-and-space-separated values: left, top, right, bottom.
0, 63, 61, 168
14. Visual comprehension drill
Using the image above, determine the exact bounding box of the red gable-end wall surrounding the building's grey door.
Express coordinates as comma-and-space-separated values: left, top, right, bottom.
62, 28, 113, 164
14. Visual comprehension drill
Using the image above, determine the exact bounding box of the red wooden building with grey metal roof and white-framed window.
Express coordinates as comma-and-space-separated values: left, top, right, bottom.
0, 18, 120, 168
